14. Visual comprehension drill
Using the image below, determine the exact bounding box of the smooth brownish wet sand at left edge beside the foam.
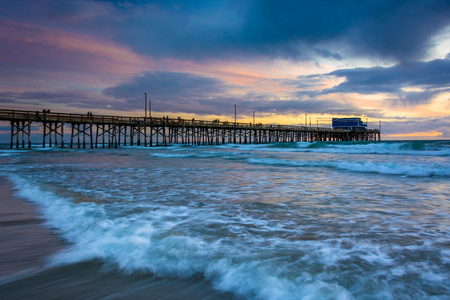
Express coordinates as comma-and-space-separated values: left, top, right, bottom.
0, 176, 64, 277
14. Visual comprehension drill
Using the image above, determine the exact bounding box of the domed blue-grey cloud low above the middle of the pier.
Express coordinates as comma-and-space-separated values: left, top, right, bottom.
103, 72, 367, 116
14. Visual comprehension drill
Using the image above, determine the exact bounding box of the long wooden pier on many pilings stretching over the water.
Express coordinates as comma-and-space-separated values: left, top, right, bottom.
0, 109, 380, 148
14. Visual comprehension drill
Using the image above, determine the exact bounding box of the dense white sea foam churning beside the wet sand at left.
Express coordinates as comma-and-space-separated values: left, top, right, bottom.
3, 176, 396, 299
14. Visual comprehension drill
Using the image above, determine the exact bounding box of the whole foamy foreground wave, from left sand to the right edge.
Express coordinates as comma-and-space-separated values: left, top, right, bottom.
5, 175, 445, 299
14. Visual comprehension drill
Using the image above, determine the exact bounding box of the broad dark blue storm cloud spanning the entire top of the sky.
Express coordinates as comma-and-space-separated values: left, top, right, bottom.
0, 0, 450, 61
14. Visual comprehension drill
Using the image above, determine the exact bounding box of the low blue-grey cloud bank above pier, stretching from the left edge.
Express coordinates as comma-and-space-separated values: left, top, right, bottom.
0, 71, 372, 116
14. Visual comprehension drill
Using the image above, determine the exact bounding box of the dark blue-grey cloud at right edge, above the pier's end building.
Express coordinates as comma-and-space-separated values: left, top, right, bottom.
323, 59, 450, 104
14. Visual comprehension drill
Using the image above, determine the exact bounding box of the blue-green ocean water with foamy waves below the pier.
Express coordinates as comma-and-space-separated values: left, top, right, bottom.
0, 140, 450, 299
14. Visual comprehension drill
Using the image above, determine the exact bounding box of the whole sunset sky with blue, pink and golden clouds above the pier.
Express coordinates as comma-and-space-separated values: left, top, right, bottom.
0, 0, 450, 140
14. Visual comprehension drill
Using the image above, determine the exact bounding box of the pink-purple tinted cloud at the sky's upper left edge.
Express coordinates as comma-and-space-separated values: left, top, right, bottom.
0, 20, 148, 74
